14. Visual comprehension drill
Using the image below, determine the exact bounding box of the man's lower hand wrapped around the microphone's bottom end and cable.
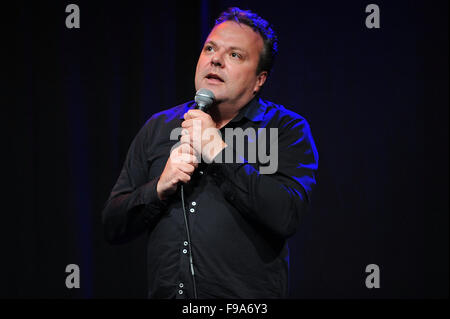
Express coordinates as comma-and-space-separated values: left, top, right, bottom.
156, 143, 198, 200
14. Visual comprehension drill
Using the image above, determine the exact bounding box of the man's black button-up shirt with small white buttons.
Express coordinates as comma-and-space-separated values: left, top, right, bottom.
103, 98, 318, 298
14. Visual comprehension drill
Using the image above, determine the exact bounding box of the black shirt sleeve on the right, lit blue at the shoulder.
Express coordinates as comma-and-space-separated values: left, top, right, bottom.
210, 118, 318, 238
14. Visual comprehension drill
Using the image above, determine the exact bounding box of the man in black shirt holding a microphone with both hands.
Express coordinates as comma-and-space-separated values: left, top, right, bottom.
103, 8, 318, 299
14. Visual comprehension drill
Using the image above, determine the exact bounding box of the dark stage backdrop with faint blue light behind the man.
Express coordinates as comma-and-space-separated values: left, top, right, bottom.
0, 0, 449, 298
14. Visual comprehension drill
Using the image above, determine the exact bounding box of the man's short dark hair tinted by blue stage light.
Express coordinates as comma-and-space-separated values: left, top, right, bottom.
215, 7, 278, 74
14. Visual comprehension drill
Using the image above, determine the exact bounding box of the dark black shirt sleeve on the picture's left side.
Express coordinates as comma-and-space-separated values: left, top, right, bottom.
102, 123, 168, 244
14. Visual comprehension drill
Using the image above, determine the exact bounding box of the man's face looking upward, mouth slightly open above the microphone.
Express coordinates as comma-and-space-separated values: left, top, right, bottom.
195, 21, 267, 106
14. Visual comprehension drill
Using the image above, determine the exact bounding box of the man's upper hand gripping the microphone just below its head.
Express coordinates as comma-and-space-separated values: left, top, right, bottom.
180, 110, 227, 163
